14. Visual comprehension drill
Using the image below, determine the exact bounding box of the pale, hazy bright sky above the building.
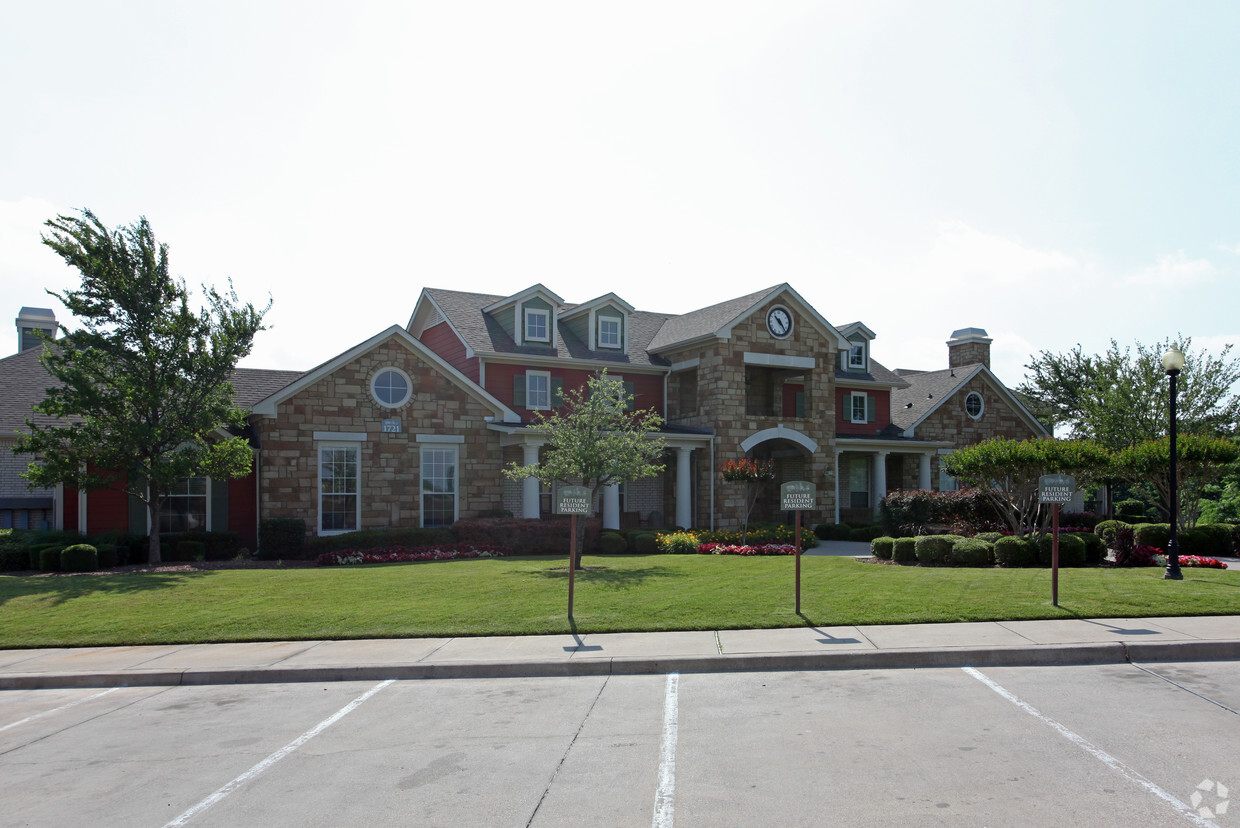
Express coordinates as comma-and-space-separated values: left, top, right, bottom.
0, 0, 1240, 385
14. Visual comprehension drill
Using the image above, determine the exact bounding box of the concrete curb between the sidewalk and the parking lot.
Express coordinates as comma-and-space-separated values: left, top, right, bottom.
0, 641, 1240, 690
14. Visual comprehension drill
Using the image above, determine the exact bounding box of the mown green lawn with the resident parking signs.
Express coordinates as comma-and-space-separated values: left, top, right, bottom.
0, 555, 1240, 647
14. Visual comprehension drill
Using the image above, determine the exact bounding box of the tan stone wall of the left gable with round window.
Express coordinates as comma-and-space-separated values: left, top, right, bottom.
258, 338, 505, 534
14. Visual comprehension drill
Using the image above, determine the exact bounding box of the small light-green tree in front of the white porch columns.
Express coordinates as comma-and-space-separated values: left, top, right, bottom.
503, 371, 663, 569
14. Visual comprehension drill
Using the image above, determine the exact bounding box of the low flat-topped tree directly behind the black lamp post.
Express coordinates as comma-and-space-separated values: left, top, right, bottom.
1116, 434, 1240, 529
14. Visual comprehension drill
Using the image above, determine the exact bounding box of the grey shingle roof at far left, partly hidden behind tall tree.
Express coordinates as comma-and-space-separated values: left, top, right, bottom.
0, 348, 303, 435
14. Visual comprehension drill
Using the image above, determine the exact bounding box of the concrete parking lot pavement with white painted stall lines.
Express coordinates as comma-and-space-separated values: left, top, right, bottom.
0, 662, 1240, 828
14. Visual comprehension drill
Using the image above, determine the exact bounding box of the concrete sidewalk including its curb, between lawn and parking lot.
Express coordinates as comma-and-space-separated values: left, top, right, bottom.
0, 616, 1240, 689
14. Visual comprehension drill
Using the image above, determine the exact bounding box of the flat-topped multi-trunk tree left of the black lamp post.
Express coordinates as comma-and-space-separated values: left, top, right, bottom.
944, 439, 1111, 538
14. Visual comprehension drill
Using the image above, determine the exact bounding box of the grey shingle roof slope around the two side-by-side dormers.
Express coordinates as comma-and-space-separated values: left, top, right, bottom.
410, 288, 671, 366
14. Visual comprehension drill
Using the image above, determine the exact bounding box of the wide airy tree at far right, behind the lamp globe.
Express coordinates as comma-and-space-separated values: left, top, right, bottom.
1018, 337, 1240, 451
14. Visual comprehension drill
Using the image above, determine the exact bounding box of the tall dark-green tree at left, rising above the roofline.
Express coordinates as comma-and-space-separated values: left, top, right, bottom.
14, 209, 270, 564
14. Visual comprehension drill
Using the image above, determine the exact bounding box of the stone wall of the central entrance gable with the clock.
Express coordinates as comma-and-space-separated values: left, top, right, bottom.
662, 300, 837, 528
